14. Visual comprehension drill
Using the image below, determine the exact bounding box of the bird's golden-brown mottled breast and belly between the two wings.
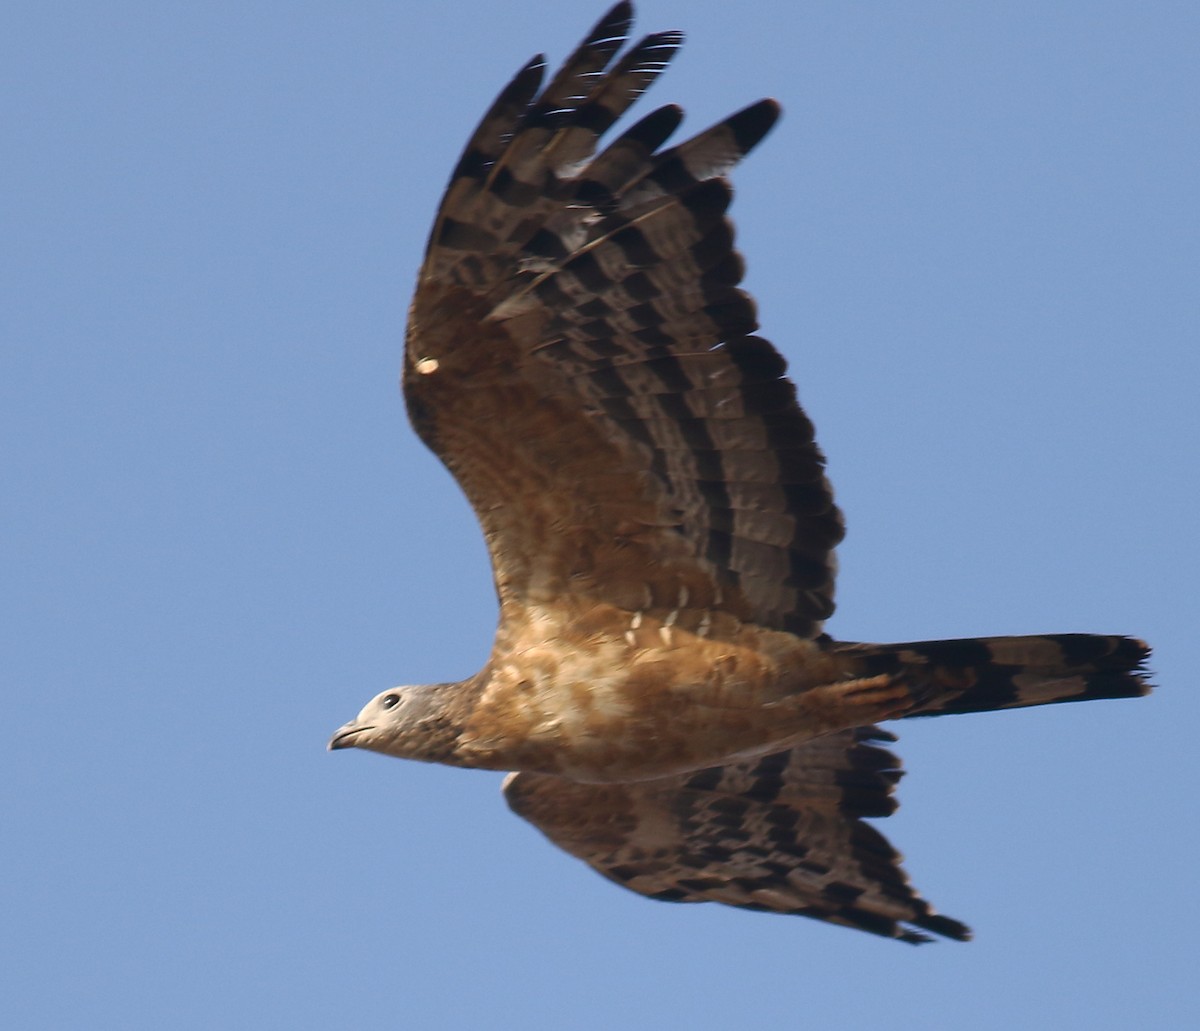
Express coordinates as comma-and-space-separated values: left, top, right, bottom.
460, 599, 836, 780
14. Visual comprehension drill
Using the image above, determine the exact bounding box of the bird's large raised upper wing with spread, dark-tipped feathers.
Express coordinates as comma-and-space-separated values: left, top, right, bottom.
404, 2, 842, 634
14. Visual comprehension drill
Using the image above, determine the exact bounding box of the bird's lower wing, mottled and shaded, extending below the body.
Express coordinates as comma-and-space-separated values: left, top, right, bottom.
504, 727, 971, 942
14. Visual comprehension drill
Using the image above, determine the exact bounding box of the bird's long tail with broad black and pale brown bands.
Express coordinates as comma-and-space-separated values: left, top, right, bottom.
835, 634, 1151, 717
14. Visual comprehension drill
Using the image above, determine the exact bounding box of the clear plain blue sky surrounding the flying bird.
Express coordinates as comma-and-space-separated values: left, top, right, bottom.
0, 0, 1200, 1031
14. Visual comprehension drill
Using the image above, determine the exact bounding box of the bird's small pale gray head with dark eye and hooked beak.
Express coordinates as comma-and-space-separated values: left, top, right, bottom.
329, 684, 461, 762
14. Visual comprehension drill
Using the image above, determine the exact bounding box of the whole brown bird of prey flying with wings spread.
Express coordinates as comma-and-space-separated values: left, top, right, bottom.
331, 2, 1147, 941
